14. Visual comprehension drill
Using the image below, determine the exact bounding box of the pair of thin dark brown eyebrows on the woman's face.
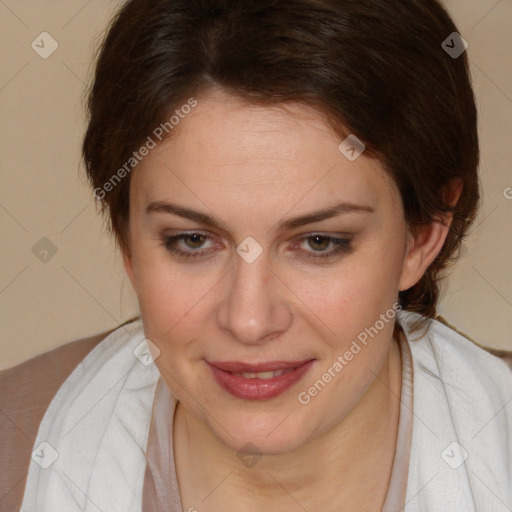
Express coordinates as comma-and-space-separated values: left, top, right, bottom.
146, 201, 375, 231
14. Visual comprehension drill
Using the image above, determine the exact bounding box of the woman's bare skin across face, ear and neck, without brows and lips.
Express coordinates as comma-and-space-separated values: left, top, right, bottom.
124, 90, 460, 512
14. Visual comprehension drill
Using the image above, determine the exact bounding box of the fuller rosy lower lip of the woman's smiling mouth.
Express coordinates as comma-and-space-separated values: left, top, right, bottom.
208, 360, 314, 400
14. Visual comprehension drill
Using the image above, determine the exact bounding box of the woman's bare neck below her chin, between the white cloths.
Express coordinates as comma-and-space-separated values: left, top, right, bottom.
174, 340, 401, 512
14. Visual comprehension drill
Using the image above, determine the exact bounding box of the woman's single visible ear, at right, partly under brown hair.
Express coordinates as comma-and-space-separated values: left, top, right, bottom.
399, 179, 463, 291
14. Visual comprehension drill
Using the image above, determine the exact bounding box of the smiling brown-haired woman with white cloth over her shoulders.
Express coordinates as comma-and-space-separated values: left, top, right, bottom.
1, 0, 512, 512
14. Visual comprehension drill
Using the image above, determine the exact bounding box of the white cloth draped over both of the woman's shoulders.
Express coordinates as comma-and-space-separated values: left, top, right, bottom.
21, 311, 512, 512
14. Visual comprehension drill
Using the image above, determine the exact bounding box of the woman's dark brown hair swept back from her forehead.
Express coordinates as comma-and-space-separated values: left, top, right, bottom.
83, 0, 480, 318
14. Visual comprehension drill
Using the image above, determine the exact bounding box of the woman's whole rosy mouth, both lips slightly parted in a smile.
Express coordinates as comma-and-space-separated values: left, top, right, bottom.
207, 359, 315, 400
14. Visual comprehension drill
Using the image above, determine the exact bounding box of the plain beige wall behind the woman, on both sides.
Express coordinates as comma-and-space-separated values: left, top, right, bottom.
0, 0, 512, 368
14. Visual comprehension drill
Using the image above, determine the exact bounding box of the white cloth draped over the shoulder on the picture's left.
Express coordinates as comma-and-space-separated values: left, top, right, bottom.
21, 321, 160, 512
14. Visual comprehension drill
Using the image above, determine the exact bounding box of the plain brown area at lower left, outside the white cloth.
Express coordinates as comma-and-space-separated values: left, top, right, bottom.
0, 331, 111, 510
